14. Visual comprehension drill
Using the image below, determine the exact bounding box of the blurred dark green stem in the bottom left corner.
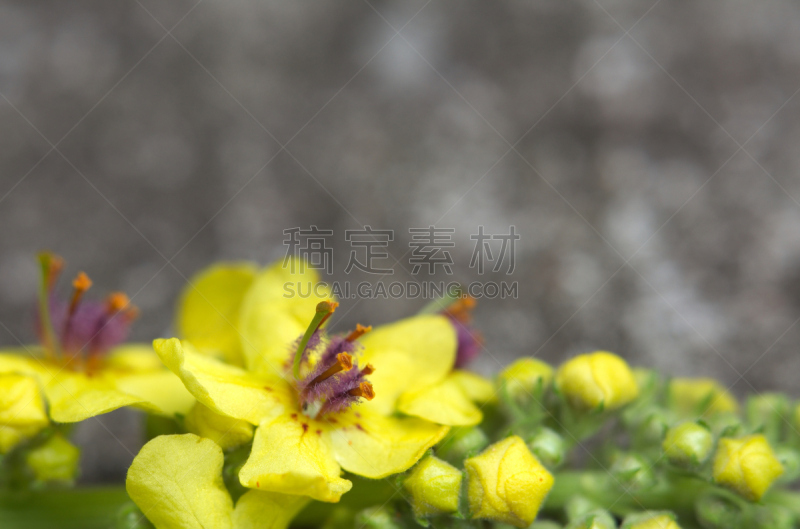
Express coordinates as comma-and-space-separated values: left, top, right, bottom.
0, 487, 131, 529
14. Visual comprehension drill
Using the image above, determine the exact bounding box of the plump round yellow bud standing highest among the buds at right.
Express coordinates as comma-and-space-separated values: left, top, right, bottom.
556, 351, 639, 410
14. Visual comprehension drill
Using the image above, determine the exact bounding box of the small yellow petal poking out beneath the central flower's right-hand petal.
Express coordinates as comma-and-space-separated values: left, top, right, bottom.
397, 376, 483, 426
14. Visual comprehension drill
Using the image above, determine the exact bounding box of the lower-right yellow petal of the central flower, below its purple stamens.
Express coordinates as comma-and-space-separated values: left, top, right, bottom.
327, 406, 450, 479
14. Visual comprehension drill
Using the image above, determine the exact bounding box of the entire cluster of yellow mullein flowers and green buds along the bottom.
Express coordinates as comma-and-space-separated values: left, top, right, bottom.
0, 255, 800, 529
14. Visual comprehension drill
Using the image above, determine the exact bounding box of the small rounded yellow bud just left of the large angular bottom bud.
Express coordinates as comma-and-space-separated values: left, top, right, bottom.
403, 456, 462, 518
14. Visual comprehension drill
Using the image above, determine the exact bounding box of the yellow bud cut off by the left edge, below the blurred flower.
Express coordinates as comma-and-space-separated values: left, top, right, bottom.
0, 374, 49, 454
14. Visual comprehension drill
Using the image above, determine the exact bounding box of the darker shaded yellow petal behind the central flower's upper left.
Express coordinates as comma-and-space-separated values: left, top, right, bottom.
176, 263, 256, 365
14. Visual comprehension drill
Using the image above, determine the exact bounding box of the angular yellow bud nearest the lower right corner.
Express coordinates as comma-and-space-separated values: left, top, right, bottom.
713, 434, 783, 501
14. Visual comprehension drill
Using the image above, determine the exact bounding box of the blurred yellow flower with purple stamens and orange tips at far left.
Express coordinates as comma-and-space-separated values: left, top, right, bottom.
0, 254, 193, 422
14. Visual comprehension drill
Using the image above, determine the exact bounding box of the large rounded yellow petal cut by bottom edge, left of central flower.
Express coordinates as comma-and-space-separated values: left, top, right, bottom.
125, 434, 233, 529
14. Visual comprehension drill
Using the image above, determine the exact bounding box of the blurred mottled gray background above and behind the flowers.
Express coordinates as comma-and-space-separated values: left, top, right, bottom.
0, 0, 800, 480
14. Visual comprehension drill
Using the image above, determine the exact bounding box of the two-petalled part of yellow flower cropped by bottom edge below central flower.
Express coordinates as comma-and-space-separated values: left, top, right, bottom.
125, 434, 308, 529
